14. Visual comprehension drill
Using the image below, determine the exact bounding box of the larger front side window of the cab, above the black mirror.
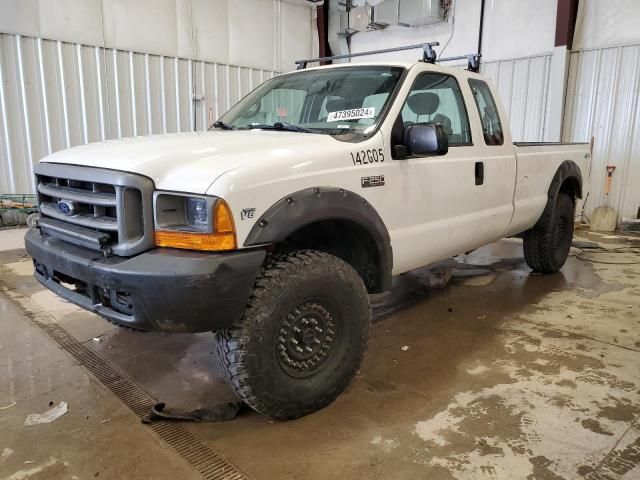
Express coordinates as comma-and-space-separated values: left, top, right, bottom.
401, 72, 471, 147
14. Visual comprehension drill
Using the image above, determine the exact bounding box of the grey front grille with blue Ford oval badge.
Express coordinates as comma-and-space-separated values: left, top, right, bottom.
35, 163, 153, 256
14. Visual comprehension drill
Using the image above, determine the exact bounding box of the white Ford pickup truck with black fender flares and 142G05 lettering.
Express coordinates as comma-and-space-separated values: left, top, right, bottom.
26, 47, 590, 419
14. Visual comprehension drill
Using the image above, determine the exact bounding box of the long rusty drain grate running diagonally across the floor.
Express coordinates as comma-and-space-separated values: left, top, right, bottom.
2, 288, 247, 480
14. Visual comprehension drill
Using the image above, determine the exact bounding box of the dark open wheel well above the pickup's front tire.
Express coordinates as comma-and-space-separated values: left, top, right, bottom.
278, 219, 384, 293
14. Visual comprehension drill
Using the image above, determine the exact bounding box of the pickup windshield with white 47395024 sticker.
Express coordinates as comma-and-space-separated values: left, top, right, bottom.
220, 66, 403, 134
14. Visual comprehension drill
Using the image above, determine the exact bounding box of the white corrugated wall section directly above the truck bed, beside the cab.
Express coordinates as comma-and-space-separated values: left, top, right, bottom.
481, 53, 551, 142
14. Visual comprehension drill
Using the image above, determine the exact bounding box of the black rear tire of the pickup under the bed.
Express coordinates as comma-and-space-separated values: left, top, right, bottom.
523, 193, 575, 273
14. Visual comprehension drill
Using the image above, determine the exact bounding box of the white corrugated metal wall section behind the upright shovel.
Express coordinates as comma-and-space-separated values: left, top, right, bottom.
563, 44, 640, 219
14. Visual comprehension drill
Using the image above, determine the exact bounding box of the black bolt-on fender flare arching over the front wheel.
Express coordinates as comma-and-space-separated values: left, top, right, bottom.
244, 187, 393, 291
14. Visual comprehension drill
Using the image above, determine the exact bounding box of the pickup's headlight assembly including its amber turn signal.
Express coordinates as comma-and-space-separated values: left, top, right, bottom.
154, 192, 236, 251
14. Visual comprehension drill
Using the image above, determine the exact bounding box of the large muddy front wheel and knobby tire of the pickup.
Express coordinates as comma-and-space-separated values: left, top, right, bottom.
216, 250, 371, 420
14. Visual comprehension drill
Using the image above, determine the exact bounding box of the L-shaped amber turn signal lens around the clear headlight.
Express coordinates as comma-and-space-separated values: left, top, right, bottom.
155, 200, 237, 252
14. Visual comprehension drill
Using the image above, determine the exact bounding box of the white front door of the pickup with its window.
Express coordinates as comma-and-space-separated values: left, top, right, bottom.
380, 71, 515, 273
